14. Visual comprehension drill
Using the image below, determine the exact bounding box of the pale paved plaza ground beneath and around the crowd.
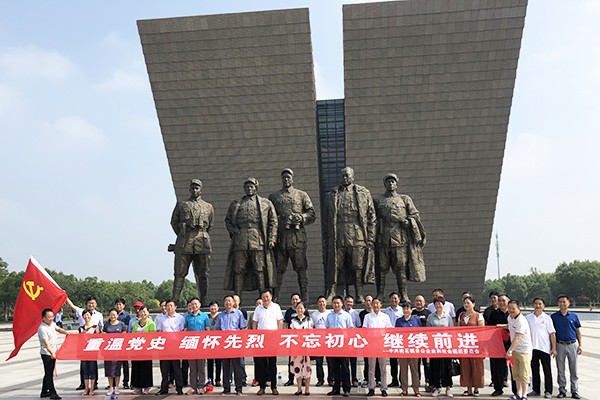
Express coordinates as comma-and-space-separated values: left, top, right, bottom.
0, 321, 600, 400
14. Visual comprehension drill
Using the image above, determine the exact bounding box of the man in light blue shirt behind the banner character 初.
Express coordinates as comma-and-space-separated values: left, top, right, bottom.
325, 296, 354, 397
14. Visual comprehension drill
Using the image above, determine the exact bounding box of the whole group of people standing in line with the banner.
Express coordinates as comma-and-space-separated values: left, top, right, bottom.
38, 289, 581, 400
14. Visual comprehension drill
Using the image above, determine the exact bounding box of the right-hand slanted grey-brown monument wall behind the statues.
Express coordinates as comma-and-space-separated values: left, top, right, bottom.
343, 0, 527, 307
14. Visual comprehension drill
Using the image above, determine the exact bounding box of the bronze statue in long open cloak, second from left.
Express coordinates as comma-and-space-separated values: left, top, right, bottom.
224, 178, 277, 296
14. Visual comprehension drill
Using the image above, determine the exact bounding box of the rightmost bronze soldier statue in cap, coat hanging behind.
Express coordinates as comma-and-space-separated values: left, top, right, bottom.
373, 173, 425, 302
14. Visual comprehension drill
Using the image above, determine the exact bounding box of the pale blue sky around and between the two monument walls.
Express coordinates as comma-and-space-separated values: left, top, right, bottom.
0, 0, 600, 283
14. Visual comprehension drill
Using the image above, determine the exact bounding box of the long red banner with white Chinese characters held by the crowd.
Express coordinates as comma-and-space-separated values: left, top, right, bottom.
56, 326, 506, 360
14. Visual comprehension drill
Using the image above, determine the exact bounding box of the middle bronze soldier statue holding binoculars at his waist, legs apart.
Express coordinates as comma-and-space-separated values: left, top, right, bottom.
269, 168, 316, 302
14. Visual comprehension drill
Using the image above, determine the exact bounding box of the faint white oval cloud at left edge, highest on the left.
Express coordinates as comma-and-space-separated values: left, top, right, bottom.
0, 46, 75, 80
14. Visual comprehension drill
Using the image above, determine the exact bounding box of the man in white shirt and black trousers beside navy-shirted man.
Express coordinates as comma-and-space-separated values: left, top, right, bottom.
525, 297, 556, 399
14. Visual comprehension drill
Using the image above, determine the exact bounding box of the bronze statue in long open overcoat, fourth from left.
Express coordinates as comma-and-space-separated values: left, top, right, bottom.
324, 167, 376, 303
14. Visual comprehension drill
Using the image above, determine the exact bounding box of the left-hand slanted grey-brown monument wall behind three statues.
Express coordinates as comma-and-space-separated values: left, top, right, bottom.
138, 9, 323, 306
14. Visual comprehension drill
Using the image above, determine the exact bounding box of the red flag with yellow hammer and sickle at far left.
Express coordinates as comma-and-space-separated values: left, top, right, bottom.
6, 257, 67, 360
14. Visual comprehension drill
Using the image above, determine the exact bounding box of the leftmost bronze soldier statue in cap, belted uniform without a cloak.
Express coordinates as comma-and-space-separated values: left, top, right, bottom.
171, 179, 214, 304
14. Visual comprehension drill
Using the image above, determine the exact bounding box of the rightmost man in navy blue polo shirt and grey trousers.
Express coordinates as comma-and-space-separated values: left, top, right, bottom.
551, 294, 581, 399
